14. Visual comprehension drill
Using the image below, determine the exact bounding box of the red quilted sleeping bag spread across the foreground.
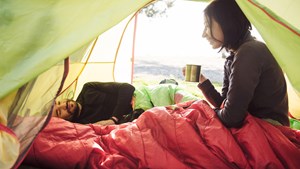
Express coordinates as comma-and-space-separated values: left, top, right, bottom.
24, 100, 300, 169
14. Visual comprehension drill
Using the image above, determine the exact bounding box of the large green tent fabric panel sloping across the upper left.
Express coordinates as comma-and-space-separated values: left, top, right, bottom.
0, 0, 149, 98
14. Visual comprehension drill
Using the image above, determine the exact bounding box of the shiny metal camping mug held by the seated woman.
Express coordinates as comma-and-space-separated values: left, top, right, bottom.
185, 64, 201, 82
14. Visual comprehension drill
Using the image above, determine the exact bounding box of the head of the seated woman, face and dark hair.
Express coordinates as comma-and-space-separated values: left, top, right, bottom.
202, 0, 252, 50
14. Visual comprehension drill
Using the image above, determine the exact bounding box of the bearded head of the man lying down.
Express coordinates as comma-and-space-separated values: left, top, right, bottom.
52, 99, 81, 121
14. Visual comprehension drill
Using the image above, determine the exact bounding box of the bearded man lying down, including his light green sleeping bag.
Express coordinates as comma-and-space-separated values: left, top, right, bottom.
52, 79, 199, 125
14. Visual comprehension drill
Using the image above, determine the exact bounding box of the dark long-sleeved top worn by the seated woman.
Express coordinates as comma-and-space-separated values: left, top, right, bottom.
198, 35, 289, 127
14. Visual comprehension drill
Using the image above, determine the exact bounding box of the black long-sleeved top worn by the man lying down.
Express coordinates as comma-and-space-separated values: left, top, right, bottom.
74, 82, 135, 124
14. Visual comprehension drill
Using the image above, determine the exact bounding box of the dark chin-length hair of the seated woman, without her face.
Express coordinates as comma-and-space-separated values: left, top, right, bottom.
204, 0, 252, 51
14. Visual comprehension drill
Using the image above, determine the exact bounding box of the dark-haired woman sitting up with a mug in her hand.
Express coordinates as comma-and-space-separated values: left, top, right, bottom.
189, 0, 289, 127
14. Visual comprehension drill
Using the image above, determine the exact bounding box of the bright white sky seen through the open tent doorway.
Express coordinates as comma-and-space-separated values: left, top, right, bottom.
91, 0, 262, 66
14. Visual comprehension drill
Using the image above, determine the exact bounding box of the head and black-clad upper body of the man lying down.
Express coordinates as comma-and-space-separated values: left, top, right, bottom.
52, 82, 135, 125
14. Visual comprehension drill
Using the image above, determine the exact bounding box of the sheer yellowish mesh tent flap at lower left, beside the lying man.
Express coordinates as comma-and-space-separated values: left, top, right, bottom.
0, 60, 70, 168
